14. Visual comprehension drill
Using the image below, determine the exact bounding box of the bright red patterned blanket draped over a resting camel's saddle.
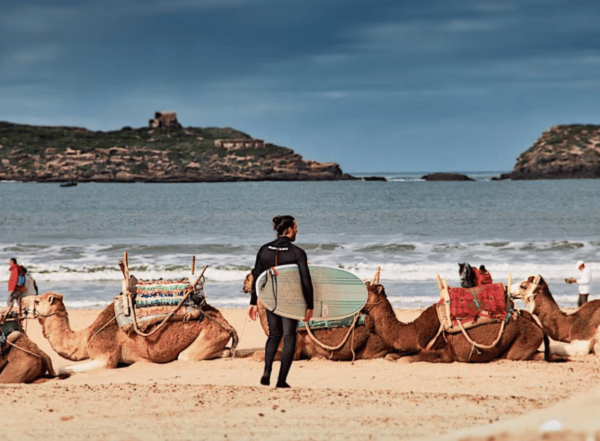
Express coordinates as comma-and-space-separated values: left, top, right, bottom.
439, 283, 508, 326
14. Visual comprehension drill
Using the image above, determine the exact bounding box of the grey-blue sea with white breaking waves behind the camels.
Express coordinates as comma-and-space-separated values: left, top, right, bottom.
0, 172, 600, 308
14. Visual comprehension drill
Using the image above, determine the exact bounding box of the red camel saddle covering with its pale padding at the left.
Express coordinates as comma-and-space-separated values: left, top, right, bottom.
437, 283, 512, 332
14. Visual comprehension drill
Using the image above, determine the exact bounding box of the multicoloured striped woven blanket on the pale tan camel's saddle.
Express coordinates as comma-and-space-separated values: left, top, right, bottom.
134, 279, 194, 318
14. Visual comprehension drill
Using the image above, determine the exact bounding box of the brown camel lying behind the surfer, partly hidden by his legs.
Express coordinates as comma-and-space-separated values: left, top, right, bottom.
254, 299, 394, 361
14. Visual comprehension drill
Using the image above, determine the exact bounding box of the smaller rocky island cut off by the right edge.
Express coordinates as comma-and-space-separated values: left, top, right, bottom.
501, 124, 600, 180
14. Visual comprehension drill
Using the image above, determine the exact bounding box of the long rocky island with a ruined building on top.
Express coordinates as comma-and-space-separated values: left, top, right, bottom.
0, 112, 354, 182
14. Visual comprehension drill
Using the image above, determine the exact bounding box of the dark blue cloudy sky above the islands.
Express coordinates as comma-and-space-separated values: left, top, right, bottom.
0, 0, 600, 173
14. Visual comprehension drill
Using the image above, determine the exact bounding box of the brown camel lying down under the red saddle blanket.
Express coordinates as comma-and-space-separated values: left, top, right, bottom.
364, 280, 564, 363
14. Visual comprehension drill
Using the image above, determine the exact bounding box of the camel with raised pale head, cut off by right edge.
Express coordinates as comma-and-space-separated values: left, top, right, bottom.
511, 276, 600, 354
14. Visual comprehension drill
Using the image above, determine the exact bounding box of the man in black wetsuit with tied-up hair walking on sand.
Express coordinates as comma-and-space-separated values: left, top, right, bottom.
248, 216, 314, 387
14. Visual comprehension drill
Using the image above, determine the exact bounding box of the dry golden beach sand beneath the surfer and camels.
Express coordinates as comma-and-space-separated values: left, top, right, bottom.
0, 309, 600, 440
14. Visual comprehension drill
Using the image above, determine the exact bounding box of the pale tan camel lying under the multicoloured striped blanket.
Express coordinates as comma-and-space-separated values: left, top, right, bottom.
24, 292, 238, 372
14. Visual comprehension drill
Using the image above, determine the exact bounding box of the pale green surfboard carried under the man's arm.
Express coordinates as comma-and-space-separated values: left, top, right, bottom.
256, 265, 368, 320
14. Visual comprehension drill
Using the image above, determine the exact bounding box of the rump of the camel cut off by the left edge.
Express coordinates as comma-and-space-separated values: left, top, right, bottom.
0, 331, 56, 383
